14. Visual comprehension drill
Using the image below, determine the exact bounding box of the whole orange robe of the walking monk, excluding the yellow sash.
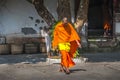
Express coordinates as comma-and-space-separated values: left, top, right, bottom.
52, 22, 80, 68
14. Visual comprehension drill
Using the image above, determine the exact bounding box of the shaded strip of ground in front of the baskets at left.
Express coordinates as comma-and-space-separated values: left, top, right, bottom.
0, 54, 47, 64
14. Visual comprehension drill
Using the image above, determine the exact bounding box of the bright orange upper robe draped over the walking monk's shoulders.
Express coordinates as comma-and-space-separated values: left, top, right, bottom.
52, 22, 80, 48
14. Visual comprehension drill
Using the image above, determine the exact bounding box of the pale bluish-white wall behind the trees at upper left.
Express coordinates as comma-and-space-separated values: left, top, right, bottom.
0, 0, 74, 34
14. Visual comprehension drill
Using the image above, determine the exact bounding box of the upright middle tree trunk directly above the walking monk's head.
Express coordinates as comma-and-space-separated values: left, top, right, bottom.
57, 0, 71, 21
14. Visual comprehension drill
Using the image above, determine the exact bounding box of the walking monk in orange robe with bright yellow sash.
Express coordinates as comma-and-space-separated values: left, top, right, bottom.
52, 17, 81, 74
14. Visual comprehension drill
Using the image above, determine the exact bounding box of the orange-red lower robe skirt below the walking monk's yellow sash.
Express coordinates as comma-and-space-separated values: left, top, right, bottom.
60, 51, 75, 68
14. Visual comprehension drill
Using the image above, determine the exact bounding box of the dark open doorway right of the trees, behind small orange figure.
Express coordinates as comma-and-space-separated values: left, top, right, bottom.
88, 0, 113, 36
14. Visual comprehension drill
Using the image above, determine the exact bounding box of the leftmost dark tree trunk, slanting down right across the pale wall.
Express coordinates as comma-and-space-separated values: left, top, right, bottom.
32, 0, 56, 27
